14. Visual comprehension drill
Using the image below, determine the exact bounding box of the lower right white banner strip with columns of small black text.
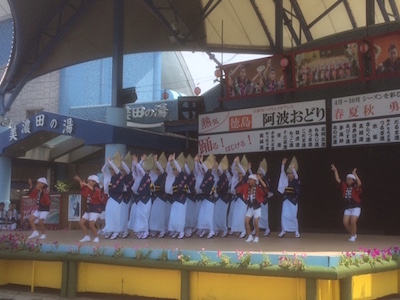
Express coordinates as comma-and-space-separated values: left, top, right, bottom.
332, 117, 400, 147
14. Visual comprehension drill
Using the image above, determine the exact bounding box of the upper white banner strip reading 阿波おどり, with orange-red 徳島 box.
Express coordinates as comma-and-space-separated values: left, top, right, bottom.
198, 100, 326, 135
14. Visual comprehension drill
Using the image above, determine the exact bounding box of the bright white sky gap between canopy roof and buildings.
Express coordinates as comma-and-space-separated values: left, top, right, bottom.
181, 52, 266, 94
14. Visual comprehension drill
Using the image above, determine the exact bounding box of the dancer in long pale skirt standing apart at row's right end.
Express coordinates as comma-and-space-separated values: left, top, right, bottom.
278, 157, 301, 238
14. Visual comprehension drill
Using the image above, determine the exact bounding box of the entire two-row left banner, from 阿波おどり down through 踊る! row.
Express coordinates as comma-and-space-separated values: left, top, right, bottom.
198, 100, 327, 154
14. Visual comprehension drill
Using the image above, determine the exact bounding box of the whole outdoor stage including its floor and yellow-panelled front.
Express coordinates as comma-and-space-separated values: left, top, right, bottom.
0, 230, 400, 300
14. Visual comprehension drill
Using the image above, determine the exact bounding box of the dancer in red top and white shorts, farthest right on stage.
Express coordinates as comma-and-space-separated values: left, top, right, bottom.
331, 164, 362, 242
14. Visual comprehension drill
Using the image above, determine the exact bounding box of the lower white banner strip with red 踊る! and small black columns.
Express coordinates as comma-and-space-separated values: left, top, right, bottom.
198, 124, 326, 154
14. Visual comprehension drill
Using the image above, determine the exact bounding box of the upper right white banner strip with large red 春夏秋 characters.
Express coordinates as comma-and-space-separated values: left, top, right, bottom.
332, 90, 400, 123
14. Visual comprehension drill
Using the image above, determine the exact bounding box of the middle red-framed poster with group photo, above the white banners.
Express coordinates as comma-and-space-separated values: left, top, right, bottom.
294, 42, 360, 88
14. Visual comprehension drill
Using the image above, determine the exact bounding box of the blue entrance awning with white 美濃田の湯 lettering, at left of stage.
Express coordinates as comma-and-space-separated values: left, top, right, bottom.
0, 112, 197, 163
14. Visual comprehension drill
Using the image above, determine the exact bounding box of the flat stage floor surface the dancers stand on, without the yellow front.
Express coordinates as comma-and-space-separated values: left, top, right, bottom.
18, 230, 400, 256
